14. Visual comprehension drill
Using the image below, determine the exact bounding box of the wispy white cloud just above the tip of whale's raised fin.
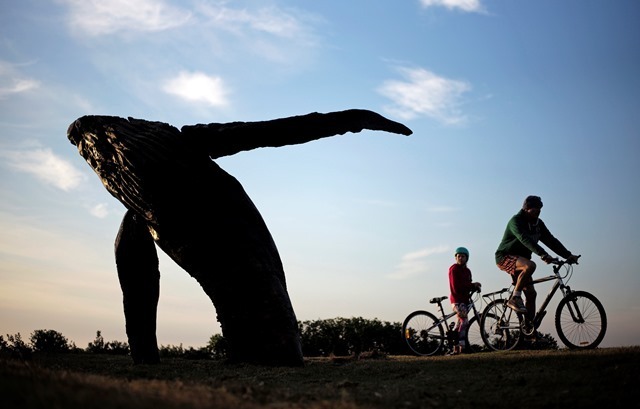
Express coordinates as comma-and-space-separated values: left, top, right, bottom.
378, 67, 471, 125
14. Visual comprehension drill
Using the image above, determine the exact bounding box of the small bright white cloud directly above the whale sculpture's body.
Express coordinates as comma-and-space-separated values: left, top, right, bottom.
163, 71, 228, 107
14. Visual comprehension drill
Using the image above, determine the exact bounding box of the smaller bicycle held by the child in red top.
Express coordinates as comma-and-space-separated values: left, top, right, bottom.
402, 291, 484, 356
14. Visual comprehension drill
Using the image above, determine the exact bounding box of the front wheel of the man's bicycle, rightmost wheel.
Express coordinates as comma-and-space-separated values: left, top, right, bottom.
556, 291, 607, 349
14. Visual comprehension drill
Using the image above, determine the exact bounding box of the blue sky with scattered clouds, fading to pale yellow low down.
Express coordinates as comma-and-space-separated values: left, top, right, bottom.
0, 0, 640, 347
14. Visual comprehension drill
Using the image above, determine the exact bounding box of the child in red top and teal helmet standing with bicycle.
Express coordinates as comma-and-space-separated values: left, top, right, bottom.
449, 247, 482, 355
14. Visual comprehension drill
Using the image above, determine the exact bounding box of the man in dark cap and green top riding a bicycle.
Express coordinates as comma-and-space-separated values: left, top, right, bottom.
495, 196, 579, 335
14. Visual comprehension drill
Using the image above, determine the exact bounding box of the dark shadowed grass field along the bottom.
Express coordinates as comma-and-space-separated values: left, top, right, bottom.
0, 347, 640, 409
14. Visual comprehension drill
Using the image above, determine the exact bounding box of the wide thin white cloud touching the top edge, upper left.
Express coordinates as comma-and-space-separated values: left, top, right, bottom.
59, 0, 191, 36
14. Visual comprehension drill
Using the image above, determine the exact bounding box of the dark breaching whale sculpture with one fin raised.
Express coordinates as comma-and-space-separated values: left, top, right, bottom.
67, 109, 412, 366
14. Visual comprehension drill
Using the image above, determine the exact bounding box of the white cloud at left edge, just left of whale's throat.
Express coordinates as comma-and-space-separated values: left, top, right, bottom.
0, 149, 86, 191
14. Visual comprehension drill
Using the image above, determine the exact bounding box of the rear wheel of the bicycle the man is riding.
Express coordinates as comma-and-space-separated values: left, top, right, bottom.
480, 299, 522, 351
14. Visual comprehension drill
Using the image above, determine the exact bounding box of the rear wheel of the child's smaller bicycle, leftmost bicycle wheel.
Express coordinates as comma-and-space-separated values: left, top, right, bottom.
402, 311, 444, 356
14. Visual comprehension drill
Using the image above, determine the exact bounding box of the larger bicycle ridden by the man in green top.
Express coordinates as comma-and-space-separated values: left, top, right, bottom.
480, 256, 607, 351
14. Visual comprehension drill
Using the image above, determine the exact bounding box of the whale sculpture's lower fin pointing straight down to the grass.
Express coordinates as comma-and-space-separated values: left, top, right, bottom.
115, 210, 160, 364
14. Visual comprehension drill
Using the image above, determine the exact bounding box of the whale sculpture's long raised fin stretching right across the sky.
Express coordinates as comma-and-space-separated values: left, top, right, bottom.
181, 109, 412, 159
